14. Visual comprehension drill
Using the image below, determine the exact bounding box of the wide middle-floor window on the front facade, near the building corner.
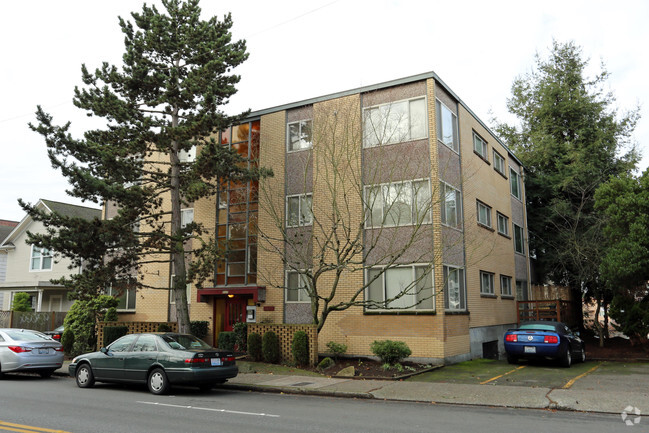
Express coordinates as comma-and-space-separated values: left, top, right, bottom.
365, 180, 431, 227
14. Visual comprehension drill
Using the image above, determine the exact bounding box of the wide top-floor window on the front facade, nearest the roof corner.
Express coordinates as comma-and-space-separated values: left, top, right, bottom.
363, 98, 428, 147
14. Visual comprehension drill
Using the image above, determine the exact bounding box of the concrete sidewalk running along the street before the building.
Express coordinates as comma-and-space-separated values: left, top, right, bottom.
55, 361, 649, 414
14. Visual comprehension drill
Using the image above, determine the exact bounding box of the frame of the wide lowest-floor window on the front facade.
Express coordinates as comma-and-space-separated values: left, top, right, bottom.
364, 263, 437, 313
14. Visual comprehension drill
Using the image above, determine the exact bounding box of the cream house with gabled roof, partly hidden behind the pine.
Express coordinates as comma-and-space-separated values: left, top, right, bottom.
0, 199, 101, 311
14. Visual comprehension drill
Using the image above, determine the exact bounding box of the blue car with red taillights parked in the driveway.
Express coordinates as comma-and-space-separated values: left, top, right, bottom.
504, 321, 586, 367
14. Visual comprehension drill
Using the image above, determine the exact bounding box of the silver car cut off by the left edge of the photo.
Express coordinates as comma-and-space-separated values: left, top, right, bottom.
0, 328, 63, 377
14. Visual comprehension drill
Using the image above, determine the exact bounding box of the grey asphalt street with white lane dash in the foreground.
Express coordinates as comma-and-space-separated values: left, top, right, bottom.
0, 375, 628, 433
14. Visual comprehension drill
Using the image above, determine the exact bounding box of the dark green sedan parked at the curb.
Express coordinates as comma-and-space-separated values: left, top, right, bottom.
69, 332, 239, 394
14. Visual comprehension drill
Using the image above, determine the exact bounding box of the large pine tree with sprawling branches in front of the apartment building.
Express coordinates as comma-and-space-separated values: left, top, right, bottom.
21, 0, 269, 332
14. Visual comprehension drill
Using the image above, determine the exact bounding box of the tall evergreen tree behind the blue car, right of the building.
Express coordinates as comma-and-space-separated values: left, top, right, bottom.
496, 41, 639, 328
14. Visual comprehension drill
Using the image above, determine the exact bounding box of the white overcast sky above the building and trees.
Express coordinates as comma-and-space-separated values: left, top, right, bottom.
0, 0, 649, 221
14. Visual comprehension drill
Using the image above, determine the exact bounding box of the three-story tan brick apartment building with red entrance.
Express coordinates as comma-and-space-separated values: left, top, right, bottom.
123, 72, 530, 362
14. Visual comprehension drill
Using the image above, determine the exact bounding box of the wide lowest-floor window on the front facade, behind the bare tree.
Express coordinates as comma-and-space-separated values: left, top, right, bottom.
365, 266, 435, 310
